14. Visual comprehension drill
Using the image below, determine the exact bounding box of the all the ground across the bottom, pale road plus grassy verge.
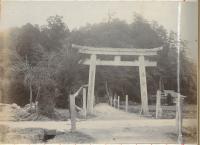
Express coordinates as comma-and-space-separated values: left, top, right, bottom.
0, 104, 197, 143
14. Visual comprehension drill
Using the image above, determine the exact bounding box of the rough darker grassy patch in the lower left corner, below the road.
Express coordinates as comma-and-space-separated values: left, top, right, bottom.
0, 125, 94, 144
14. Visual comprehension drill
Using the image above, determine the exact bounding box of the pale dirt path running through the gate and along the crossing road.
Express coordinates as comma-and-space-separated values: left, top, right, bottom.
0, 104, 196, 143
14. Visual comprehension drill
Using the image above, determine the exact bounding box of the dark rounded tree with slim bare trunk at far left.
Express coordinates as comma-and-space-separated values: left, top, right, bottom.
10, 24, 42, 110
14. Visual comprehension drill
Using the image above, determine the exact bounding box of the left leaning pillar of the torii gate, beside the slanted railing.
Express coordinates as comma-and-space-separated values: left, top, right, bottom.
87, 54, 96, 114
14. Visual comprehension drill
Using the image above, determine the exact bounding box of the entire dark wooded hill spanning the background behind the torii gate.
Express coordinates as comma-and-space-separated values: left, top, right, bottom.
0, 15, 197, 114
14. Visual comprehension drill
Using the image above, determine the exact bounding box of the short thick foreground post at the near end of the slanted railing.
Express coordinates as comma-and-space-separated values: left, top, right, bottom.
70, 94, 76, 132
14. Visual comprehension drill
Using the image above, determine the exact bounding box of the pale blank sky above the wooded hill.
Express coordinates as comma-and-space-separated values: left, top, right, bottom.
0, 0, 198, 60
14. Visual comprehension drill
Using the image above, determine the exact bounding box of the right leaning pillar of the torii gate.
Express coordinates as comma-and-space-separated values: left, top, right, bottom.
139, 55, 149, 115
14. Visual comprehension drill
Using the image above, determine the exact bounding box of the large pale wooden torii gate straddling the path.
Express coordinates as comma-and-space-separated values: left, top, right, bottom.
72, 44, 162, 115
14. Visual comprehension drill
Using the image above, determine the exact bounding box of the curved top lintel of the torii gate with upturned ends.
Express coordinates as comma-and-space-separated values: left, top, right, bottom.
72, 44, 162, 56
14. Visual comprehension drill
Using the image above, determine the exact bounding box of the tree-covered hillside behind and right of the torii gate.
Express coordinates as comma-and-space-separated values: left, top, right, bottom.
71, 14, 196, 103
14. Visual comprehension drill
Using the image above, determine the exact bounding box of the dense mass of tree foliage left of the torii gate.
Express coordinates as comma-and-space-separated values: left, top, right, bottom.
10, 16, 78, 116
